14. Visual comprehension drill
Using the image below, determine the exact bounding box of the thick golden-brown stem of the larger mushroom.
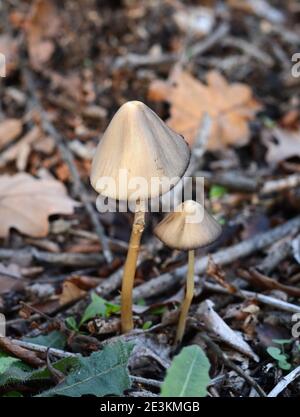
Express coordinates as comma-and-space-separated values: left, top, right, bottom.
121, 209, 145, 333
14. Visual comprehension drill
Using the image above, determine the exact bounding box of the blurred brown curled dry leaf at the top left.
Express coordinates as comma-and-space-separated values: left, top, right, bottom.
26, 0, 60, 68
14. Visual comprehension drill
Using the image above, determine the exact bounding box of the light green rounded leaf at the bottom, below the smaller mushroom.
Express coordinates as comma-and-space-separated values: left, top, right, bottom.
161, 345, 210, 397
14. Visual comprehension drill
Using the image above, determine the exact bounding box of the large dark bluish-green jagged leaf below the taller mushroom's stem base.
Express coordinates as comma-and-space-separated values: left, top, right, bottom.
39, 342, 133, 397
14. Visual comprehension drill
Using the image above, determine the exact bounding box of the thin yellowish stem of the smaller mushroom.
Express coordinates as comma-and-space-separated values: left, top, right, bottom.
175, 249, 195, 343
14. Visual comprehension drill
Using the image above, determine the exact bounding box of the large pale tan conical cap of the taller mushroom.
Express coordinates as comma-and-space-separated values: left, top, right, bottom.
91, 101, 190, 200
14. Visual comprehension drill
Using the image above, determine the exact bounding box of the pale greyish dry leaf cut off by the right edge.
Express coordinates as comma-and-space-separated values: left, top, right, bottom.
263, 128, 300, 164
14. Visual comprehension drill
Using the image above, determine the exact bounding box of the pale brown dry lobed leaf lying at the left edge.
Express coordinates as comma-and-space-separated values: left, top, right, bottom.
0, 173, 78, 237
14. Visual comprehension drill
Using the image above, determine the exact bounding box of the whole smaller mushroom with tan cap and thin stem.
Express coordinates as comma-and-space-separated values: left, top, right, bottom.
154, 200, 222, 343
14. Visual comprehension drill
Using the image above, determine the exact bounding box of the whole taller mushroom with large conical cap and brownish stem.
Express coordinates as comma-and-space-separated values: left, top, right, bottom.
90, 101, 190, 332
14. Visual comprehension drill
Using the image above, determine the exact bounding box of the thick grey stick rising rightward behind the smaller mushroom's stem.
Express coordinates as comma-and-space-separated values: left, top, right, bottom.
133, 216, 300, 300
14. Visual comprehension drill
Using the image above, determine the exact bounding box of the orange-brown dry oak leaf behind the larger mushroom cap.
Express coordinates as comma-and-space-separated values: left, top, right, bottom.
149, 68, 260, 150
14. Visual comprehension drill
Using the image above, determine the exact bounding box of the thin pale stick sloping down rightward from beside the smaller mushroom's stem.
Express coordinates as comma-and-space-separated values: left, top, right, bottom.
204, 282, 300, 313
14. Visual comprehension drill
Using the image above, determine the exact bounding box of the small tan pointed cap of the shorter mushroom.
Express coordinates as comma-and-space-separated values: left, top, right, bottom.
154, 200, 222, 250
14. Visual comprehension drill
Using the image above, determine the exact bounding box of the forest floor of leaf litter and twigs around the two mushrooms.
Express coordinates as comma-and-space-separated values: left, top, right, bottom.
0, 0, 300, 397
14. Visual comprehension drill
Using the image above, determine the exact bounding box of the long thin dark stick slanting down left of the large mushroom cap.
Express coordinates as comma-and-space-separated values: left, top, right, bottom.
23, 68, 113, 262
